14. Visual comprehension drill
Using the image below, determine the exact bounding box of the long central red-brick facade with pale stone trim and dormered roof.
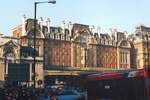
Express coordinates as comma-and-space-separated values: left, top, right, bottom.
44, 23, 131, 73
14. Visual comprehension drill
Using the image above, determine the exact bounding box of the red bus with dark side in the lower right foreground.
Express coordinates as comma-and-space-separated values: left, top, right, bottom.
86, 69, 150, 100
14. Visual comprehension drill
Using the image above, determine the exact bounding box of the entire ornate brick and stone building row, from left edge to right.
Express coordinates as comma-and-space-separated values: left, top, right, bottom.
0, 16, 149, 86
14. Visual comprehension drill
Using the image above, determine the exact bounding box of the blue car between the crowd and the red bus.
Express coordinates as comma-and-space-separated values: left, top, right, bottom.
57, 89, 83, 100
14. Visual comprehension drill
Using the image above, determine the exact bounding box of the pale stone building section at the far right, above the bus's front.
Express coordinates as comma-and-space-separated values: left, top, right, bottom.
131, 25, 150, 68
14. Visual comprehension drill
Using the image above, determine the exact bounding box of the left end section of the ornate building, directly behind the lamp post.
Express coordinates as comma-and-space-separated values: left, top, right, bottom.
9, 16, 44, 86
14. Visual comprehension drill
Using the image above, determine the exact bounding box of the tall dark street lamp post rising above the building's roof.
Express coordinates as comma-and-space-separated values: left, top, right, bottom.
33, 0, 56, 87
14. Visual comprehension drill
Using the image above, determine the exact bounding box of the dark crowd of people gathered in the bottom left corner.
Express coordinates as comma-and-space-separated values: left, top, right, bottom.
0, 86, 57, 100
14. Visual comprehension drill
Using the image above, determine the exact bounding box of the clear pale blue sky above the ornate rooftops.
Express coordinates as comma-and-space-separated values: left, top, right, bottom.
0, 0, 150, 35
